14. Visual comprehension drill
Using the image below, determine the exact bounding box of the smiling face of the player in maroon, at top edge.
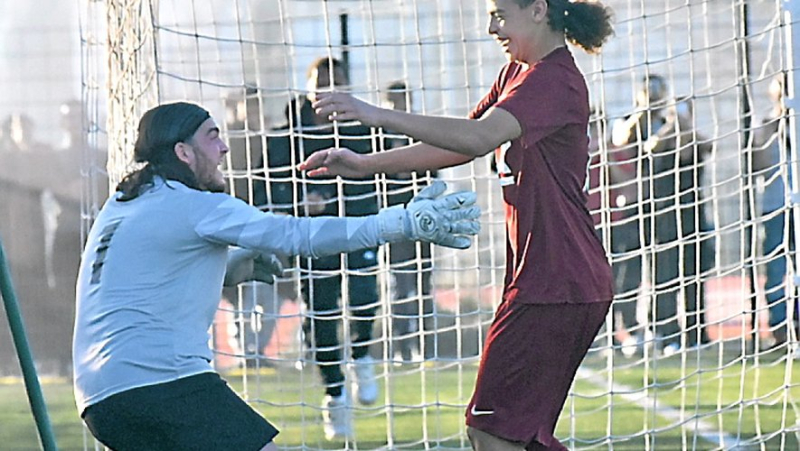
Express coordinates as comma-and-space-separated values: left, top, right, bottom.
486, 0, 544, 62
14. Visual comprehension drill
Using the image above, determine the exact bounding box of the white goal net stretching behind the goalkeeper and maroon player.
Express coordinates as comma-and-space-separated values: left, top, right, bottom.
81, 0, 800, 450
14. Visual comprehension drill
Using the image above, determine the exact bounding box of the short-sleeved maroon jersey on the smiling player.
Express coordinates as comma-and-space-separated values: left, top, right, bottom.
470, 47, 613, 304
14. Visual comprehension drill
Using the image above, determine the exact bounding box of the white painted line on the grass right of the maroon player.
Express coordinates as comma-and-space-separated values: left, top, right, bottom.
578, 367, 739, 450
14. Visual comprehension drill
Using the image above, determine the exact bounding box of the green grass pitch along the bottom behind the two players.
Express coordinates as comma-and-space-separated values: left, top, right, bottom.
0, 351, 800, 451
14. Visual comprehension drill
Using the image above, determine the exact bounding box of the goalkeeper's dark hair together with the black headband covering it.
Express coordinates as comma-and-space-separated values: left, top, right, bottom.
117, 102, 211, 201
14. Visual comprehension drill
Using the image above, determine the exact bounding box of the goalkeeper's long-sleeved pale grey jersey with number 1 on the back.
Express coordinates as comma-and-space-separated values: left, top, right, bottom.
73, 180, 404, 412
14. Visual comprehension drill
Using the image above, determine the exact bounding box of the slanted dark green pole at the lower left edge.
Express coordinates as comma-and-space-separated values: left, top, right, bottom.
0, 239, 58, 451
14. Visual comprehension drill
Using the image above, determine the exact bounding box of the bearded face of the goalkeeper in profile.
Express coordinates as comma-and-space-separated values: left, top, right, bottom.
184, 118, 228, 193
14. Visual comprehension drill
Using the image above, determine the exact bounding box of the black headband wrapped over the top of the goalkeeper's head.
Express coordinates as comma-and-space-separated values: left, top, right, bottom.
133, 102, 211, 163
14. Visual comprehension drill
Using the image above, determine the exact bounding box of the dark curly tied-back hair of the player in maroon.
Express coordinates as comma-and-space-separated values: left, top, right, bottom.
515, 0, 614, 53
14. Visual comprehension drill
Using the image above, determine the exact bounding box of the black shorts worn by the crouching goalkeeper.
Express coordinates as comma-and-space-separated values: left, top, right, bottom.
82, 373, 278, 451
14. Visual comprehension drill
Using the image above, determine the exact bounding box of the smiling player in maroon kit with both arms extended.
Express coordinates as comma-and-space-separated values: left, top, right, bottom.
301, 0, 614, 451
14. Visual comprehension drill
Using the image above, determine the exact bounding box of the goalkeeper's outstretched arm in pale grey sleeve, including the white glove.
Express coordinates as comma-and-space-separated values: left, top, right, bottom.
196, 181, 481, 262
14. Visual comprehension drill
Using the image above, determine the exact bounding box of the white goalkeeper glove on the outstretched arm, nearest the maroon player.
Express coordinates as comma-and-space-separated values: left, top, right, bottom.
378, 180, 481, 249
